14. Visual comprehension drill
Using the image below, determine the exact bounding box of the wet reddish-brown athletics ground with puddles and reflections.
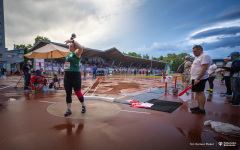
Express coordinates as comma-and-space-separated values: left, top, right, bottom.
0, 75, 240, 150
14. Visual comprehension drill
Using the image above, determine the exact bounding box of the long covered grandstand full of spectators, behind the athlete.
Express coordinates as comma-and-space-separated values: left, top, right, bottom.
30, 41, 169, 70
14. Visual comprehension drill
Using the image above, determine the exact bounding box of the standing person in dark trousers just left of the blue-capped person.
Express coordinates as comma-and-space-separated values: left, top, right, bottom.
224, 57, 232, 96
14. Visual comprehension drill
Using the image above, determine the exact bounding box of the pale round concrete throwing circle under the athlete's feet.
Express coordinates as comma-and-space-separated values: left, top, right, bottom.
47, 100, 122, 119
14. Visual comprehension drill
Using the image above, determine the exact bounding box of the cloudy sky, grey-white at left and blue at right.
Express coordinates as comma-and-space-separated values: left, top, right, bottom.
4, 0, 240, 59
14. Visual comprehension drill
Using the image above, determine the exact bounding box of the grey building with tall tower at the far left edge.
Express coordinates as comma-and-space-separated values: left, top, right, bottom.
0, 0, 24, 74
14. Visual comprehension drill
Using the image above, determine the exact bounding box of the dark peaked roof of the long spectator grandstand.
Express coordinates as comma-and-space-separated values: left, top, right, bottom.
30, 41, 168, 69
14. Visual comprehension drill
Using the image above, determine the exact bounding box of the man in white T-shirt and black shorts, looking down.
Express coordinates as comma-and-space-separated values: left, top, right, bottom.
190, 45, 212, 114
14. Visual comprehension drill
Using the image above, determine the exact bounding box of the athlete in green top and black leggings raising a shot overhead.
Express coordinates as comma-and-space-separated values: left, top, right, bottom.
64, 34, 86, 116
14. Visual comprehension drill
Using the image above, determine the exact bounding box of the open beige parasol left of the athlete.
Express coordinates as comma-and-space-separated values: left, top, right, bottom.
24, 43, 69, 71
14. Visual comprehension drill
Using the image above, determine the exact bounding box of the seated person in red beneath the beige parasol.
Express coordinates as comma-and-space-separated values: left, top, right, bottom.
30, 76, 46, 91
